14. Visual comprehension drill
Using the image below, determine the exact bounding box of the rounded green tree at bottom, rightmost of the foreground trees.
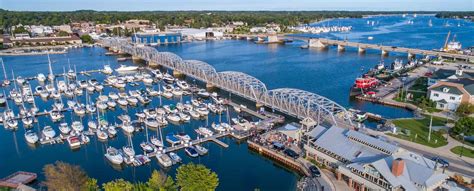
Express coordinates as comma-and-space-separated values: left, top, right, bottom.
176, 163, 219, 191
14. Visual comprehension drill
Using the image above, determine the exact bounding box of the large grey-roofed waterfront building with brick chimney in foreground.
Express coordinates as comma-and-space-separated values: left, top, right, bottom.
304, 126, 448, 190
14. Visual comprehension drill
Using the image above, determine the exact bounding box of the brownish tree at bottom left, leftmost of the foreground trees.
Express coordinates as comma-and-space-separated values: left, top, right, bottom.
43, 161, 89, 191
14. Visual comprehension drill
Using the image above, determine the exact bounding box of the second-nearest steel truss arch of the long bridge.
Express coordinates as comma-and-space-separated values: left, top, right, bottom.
218, 71, 267, 103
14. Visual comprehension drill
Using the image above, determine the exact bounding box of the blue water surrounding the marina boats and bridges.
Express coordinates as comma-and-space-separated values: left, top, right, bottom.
0, 16, 474, 190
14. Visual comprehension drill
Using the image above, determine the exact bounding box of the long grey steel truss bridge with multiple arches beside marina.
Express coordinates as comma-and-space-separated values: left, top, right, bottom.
102, 39, 353, 127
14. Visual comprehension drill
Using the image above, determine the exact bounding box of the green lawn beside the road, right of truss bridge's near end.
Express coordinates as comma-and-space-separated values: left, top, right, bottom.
387, 117, 448, 148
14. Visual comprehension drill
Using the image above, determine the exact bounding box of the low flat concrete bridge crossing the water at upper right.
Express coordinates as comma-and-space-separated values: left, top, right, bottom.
302, 37, 474, 62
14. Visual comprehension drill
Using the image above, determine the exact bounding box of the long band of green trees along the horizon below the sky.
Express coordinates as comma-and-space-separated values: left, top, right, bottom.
0, 9, 440, 29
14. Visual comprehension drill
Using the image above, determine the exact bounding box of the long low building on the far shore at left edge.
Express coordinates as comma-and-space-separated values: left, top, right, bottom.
3, 35, 82, 48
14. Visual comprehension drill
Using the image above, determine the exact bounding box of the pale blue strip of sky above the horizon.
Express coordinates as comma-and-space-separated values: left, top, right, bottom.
0, 0, 474, 11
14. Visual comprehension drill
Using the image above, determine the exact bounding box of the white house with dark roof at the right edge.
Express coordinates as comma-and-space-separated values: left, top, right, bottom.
428, 78, 474, 111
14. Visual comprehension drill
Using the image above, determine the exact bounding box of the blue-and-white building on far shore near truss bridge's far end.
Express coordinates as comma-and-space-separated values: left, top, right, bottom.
132, 32, 182, 45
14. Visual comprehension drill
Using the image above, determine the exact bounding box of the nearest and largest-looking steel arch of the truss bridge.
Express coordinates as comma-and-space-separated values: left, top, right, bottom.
265, 88, 352, 125
